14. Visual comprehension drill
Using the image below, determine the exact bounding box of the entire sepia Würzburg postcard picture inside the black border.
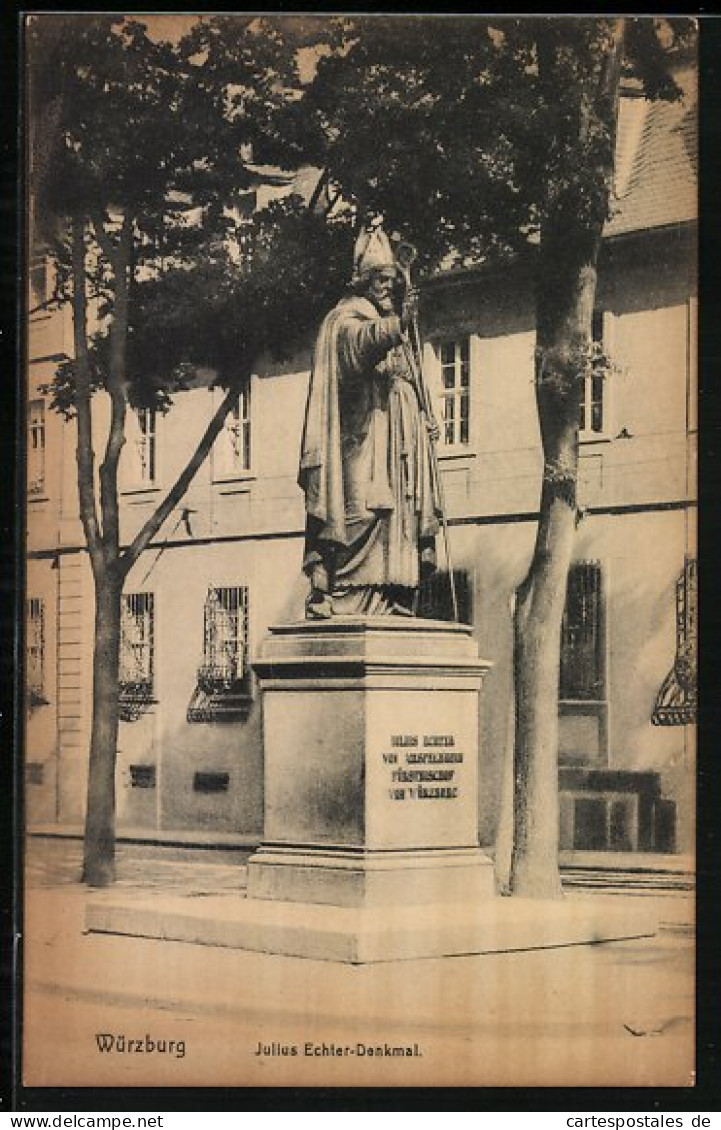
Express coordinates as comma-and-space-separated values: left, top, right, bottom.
24, 11, 698, 1088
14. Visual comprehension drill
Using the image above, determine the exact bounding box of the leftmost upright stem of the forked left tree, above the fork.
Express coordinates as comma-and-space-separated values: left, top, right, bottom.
72, 216, 102, 564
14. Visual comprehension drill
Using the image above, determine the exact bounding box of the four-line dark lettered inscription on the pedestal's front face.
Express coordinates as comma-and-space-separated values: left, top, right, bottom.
383, 733, 463, 801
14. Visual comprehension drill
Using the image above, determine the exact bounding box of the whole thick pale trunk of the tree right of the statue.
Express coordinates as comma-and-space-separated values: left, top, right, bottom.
510, 17, 625, 898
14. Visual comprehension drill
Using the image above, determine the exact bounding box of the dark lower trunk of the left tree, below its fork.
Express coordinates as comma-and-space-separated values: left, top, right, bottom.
82, 566, 122, 887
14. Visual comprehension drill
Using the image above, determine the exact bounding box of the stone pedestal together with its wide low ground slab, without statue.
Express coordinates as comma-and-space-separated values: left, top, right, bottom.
86, 618, 657, 964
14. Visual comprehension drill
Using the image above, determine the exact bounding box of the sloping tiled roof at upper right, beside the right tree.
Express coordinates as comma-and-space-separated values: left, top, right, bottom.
605, 69, 698, 236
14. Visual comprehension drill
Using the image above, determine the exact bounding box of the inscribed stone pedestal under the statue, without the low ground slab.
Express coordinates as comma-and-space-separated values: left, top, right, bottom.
247, 617, 494, 914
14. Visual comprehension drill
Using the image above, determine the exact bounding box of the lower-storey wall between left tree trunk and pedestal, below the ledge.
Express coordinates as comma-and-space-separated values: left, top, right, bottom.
119, 528, 302, 835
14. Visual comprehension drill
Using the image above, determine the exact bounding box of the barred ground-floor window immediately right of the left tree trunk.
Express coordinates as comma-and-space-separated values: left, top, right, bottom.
120, 592, 155, 722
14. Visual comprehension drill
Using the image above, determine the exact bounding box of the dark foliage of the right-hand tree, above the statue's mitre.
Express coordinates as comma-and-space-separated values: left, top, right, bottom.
293, 16, 690, 273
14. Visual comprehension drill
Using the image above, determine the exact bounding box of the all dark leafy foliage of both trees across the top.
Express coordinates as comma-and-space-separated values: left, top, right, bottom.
28, 16, 693, 410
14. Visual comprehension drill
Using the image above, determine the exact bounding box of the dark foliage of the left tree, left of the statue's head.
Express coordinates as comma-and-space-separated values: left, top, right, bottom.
28, 15, 350, 414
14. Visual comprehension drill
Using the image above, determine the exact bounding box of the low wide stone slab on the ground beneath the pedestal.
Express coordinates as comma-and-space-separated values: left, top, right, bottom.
86, 895, 658, 965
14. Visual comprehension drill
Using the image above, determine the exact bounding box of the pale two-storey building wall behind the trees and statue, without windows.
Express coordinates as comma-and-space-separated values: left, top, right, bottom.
27, 222, 695, 846
